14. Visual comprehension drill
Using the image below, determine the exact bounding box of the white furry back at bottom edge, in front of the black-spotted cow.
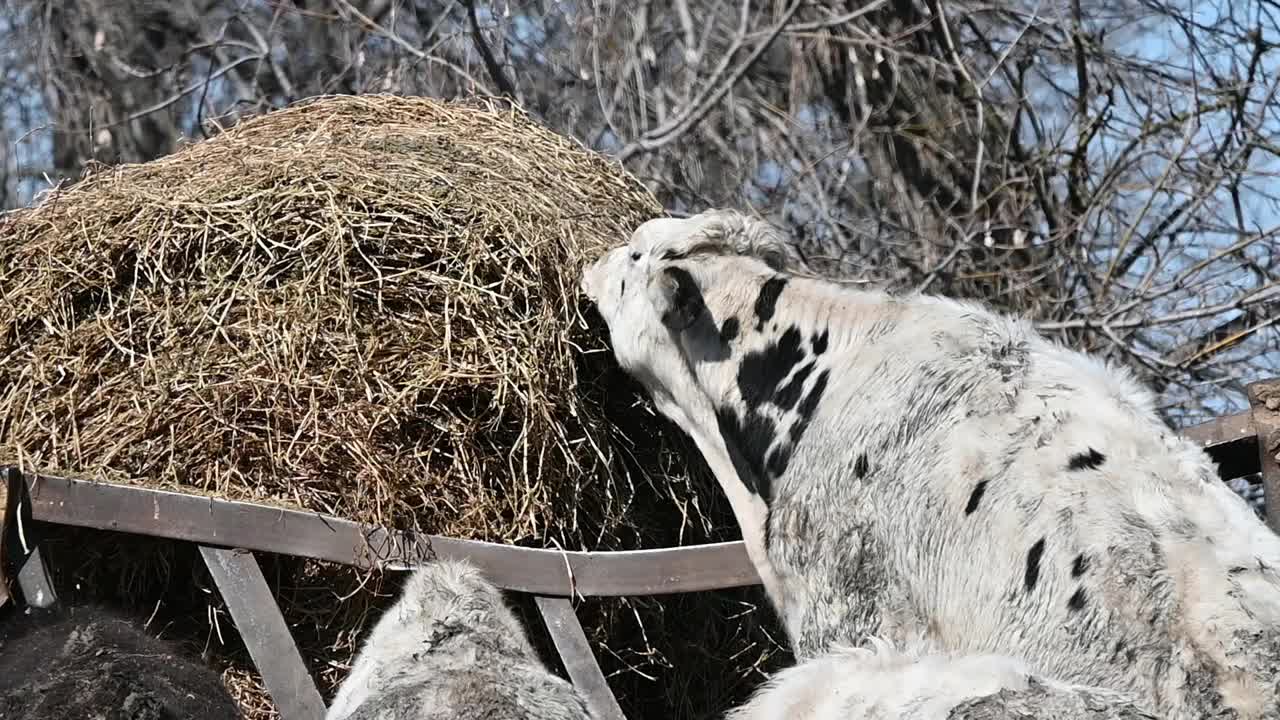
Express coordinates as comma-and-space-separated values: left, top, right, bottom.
724, 638, 1156, 720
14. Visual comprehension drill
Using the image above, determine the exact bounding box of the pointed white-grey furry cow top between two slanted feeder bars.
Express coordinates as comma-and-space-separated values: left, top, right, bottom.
325, 561, 591, 720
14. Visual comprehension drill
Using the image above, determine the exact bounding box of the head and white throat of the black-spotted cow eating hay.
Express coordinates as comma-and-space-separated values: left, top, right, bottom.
581, 210, 800, 611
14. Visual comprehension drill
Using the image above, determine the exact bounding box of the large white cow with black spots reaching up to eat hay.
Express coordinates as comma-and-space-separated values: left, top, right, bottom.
582, 211, 1280, 720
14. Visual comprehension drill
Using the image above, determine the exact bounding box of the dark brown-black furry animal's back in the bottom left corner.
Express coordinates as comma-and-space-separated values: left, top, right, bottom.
0, 606, 241, 720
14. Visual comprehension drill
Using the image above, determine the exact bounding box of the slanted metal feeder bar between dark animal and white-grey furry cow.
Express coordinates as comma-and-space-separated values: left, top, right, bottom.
200, 544, 325, 720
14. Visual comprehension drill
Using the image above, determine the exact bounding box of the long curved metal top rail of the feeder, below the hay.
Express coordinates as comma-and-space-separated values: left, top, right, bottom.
17, 475, 759, 597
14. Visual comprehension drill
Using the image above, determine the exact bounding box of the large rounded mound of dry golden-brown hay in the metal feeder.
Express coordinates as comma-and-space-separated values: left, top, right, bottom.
0, 96, 776, 716
